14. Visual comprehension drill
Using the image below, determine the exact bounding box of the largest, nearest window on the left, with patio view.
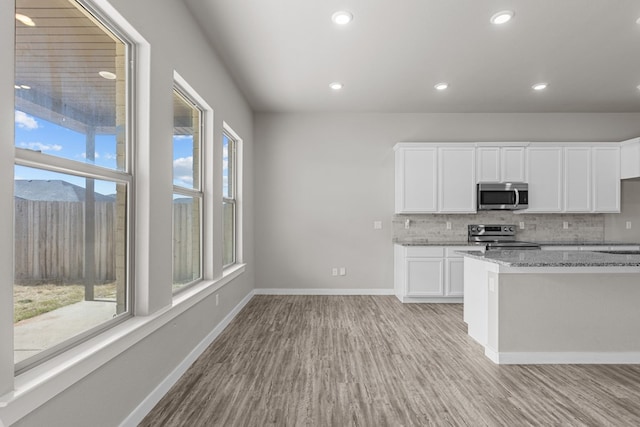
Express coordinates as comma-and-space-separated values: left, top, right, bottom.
14, 0, 133, 372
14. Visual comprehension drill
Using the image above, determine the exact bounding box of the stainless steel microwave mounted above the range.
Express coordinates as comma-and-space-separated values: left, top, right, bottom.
478, 182, 529, 211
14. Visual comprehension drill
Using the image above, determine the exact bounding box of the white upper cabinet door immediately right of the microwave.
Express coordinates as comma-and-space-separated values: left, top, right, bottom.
527, 147, 563, 212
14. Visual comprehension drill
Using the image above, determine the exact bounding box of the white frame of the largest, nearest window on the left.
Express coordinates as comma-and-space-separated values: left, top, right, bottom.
14, 0, 137, 375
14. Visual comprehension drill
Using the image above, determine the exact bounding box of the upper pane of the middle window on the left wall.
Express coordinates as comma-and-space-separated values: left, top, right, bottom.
173, 91, 200, 190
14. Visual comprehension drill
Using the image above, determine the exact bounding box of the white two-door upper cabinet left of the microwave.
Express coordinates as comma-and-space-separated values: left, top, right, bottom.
394, 143, 476, 213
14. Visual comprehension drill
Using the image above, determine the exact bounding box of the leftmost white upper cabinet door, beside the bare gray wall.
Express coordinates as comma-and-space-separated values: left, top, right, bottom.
396, 147, 438, 213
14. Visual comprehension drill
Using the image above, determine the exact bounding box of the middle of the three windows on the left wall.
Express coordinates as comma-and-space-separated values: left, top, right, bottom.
173, 88, 203, 293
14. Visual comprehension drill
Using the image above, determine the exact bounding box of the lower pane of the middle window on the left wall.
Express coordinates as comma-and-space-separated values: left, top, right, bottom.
173, 194, 201, 292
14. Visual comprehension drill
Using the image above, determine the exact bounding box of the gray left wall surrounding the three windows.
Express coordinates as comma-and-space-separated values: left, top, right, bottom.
5, 0, 254, 426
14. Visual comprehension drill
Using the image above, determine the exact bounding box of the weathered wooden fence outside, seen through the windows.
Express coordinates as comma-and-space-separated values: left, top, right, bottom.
15, 199, 199, 284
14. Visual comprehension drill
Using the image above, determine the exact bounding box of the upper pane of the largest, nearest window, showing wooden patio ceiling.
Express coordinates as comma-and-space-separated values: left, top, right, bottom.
15, 0, 126, 170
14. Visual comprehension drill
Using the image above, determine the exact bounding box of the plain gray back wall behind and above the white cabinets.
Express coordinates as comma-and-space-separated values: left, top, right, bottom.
255, 113, 640, 289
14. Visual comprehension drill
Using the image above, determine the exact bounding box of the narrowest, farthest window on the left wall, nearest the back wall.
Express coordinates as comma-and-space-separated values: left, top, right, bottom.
222, 128, 239, 267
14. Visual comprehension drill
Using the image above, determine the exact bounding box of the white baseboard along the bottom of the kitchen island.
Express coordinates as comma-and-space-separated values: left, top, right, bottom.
484, 348, 640, 365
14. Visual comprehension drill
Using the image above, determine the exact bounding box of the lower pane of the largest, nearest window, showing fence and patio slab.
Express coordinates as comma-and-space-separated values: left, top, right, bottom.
14, 166, 128, 363
